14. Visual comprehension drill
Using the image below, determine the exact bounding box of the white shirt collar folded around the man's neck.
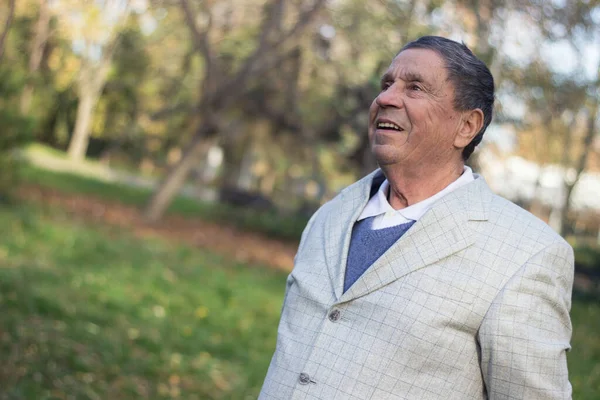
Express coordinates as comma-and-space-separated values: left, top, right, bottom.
357, 166, 475, 221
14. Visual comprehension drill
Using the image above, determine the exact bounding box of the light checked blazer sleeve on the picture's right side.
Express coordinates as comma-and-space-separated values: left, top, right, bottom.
478, 242, 574, 400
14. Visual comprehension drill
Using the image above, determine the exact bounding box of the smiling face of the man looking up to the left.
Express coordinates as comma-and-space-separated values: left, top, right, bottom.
369, 49, 461, 170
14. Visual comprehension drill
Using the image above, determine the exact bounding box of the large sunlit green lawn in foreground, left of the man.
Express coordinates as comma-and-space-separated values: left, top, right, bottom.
0, 205, 285, 400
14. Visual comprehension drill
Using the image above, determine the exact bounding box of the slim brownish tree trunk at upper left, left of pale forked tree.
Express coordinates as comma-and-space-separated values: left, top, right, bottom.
21, 0, 50, 114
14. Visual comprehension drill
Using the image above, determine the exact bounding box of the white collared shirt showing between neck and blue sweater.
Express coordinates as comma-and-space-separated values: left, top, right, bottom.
357, 166, 475, 229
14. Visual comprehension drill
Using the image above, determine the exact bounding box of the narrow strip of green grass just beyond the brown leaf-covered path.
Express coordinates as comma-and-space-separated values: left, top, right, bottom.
21, 165, 308, 241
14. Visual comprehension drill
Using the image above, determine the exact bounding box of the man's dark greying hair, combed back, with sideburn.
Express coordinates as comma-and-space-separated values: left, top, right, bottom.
398, 36, 494, 161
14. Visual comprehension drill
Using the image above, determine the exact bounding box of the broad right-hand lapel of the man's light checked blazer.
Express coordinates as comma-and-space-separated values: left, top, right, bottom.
337, 175, 492, 302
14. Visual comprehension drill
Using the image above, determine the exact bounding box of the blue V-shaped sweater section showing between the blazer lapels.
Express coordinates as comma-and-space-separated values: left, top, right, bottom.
344, 217, 415, 292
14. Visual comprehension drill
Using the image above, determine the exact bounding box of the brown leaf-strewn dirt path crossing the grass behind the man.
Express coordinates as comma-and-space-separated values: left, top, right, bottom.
18, 185, 297, 271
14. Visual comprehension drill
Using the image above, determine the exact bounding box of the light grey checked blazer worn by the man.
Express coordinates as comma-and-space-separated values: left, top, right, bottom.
259, 170, 574, 400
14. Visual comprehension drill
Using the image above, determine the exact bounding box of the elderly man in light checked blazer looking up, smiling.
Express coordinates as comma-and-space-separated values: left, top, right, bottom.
260, 37, 573, 400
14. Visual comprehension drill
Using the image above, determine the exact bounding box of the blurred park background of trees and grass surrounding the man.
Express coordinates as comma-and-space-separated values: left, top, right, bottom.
0, 0, 600, 400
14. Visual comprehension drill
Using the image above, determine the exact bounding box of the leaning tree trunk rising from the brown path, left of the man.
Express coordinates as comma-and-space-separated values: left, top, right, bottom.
144, 127, 210, 222
